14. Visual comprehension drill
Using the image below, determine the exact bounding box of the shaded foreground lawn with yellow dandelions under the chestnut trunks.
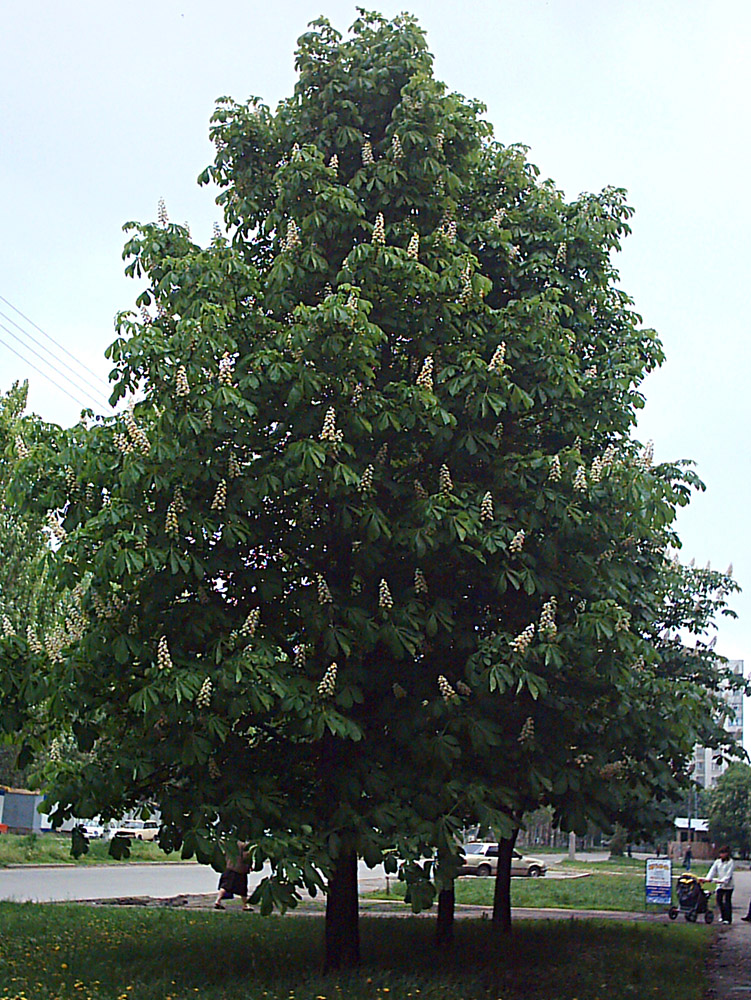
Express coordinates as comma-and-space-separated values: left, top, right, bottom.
0, 903, 713, 1000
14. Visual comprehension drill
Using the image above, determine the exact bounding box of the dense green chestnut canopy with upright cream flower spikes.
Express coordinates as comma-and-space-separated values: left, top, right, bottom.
2, 12, 733, 940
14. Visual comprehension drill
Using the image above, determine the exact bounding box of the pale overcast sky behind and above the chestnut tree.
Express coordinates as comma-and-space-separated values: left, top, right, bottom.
0, 0, 751, 680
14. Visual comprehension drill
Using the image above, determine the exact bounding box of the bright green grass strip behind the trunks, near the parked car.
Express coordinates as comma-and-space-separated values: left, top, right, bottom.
378, 872, 672, 911
